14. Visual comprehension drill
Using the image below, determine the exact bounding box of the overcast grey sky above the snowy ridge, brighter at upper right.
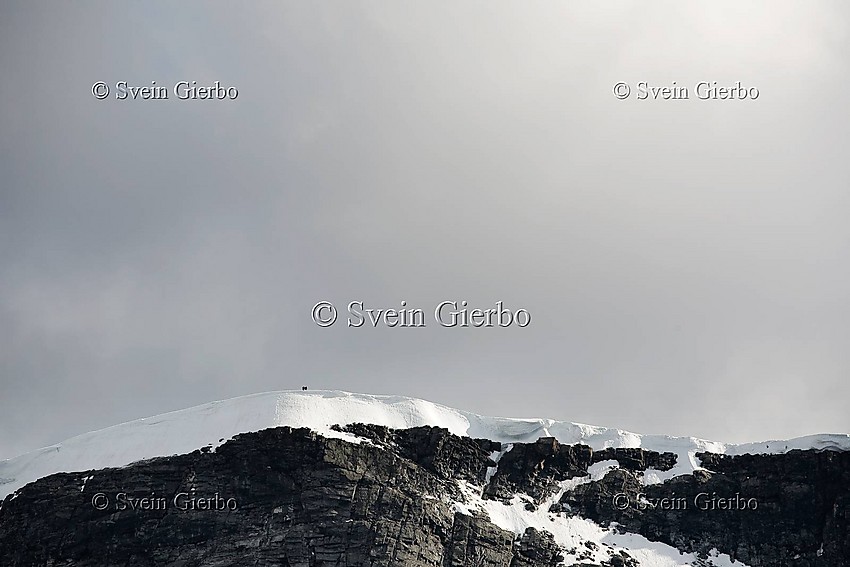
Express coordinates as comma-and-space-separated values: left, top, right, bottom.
0, 0, 850, 458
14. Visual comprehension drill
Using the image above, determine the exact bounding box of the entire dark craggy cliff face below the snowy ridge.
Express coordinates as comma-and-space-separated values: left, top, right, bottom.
0, 425, 850, 567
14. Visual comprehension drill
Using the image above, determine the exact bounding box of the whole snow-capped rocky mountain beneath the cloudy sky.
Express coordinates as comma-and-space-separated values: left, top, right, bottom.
0, 391, 850, 567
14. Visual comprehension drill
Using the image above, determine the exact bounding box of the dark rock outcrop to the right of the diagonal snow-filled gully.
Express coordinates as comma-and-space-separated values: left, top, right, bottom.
557, 450, 850, 567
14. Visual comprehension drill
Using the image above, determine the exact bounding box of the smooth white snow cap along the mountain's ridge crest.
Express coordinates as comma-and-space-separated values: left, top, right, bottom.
0, 390, 850, 498
